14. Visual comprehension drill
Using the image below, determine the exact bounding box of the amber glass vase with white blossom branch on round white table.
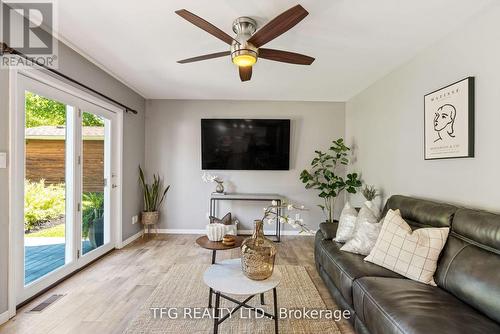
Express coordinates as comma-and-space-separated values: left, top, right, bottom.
241, 202, 313, 280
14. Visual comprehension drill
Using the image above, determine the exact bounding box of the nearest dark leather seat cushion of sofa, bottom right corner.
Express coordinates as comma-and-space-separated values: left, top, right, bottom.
353, 277, 500, 334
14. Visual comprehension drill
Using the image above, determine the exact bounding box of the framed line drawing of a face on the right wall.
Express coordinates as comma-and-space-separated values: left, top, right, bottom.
424, 77, 474, 160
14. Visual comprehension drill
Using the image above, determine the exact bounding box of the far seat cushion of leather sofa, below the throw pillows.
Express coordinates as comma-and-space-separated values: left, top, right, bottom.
320, 240, 402, 305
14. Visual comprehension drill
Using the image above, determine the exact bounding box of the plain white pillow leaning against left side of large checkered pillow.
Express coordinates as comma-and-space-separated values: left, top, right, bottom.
340, 204, 382, 255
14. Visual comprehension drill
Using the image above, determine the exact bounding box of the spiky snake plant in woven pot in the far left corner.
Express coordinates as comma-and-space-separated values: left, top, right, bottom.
139, 166, 170, 225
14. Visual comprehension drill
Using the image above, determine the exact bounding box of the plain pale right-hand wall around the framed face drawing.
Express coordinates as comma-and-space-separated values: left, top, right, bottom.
346, 6, 500, 211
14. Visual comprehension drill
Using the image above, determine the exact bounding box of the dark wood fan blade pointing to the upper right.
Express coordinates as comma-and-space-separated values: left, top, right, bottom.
248, 5, 309, 47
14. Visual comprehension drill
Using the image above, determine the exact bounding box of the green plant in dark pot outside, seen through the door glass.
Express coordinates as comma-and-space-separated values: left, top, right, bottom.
82, 192, 104, 249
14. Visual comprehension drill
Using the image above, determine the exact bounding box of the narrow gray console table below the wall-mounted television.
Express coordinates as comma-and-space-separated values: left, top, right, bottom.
209, 193, 283, 242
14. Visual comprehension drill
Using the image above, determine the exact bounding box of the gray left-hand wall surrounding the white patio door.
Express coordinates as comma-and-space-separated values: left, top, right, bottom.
0, 43, 145, 313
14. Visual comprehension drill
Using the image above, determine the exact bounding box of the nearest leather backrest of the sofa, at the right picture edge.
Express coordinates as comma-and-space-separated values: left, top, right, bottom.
434, 209, 500, 322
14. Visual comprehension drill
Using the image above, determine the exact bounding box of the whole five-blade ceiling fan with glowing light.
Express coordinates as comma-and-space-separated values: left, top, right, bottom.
175, 5, 314, 81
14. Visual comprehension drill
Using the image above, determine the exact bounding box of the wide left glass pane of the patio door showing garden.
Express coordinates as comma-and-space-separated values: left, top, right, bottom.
24, 90, 73, 285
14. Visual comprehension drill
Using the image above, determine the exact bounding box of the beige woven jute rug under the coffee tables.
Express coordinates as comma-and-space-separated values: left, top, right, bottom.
125, 264, 340, 334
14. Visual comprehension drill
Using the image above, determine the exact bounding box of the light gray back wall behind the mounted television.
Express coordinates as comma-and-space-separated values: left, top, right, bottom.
146, 100, 345, 234
